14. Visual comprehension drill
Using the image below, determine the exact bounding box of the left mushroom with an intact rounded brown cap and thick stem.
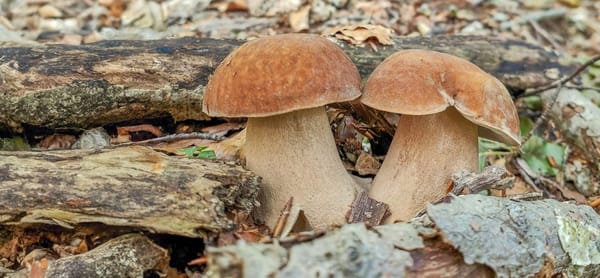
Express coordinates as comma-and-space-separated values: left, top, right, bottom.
203, 34, 361, 228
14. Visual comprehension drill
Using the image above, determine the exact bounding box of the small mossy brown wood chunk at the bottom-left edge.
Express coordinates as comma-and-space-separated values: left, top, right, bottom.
43, 234, 169, 278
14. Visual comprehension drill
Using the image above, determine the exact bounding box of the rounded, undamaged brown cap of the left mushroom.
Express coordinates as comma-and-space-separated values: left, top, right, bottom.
202, 34, 361, 117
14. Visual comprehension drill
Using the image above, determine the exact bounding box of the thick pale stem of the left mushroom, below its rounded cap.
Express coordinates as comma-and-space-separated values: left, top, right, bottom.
244, 107, 357, 229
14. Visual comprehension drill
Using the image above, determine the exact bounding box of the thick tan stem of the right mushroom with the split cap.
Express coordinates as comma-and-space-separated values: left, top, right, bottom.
369, 108, 478, 223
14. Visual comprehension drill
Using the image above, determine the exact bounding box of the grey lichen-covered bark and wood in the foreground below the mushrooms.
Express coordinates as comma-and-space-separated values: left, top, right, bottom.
207, 194, 600, 277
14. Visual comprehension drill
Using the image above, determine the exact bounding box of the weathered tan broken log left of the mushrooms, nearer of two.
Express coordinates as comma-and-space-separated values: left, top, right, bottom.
0, 147, 260, 237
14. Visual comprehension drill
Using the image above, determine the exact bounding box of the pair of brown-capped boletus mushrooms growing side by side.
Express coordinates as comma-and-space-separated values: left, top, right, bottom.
203, 34, 520, 228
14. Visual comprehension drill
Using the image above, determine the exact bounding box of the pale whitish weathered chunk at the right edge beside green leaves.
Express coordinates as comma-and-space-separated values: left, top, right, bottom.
542, 88, 600, 196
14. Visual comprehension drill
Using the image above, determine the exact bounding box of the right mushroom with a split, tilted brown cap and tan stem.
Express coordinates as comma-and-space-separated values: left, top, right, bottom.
360, 50, 520, 222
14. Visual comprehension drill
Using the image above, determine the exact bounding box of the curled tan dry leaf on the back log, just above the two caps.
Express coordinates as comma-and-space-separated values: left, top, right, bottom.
323, 24, 394, 45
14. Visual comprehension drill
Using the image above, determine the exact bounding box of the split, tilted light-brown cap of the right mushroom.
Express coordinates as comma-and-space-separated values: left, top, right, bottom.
361, 50, 520, 145
